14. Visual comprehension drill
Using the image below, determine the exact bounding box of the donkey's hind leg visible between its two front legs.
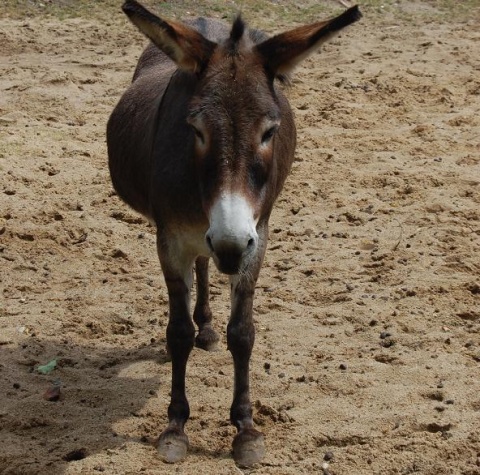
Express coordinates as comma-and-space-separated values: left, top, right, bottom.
193, 257, 220, 351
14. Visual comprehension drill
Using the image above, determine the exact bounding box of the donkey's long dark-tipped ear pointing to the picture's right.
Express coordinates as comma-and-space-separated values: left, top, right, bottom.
256, 6, 362, 76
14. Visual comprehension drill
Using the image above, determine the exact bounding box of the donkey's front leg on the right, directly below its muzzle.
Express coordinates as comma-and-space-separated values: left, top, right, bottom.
227, 276, 265, 467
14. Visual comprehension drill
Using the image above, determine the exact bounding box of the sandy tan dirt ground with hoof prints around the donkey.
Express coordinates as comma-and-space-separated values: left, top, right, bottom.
0, 2, 480, 475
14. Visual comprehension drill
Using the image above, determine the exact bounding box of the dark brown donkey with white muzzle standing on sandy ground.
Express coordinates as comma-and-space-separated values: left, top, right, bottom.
107, 0, 361, 466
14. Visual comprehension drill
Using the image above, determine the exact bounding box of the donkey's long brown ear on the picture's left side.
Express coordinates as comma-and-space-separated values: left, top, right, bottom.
122, 0, 216, 72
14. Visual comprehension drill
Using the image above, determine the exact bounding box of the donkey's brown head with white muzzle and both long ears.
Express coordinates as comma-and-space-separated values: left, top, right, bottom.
123, 0, 360, 274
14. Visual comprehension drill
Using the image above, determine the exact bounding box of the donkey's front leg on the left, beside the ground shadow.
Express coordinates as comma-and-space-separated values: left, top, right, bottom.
157, 242, 195, 463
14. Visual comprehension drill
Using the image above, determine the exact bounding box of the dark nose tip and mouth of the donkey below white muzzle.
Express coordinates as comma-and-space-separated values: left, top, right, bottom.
205, 229, 258, 274
